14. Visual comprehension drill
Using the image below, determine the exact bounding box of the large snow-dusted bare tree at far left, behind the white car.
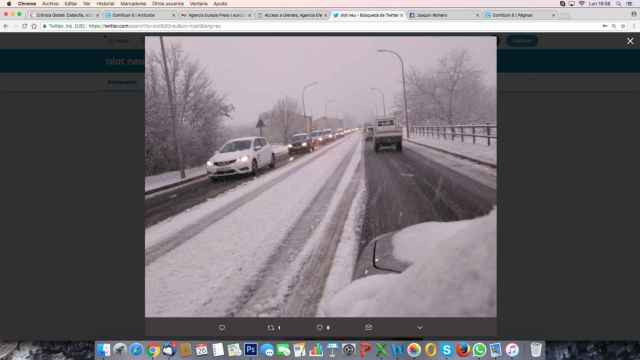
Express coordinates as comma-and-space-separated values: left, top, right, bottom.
145, 39, 233, 175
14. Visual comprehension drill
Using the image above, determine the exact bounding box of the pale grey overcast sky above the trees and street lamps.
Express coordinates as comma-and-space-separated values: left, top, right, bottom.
147, 36, 496, 126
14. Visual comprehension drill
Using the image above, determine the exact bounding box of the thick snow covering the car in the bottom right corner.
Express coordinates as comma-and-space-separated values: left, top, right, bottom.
324, 209, 497, 317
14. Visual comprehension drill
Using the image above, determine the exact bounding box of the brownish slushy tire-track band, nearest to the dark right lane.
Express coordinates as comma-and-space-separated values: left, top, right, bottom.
230, 139, 363, 317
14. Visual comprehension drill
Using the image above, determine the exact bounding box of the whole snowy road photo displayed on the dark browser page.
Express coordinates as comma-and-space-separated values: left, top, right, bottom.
144, 35, 498, 318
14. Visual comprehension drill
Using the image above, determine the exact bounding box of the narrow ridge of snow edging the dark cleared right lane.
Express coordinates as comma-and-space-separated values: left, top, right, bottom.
318, 177, 367, 317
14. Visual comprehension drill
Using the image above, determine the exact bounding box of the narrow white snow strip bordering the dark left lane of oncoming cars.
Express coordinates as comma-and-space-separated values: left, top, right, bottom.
145, 138, 344, 249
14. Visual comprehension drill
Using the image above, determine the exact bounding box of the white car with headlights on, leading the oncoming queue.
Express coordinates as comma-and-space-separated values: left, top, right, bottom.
207, 137, 276, 179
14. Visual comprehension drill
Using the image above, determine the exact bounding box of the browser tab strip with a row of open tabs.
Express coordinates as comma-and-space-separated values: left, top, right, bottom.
0, 6, 640, 22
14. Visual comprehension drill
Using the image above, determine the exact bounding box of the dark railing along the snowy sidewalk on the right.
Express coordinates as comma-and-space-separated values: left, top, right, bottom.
410, 124, 498, 146
